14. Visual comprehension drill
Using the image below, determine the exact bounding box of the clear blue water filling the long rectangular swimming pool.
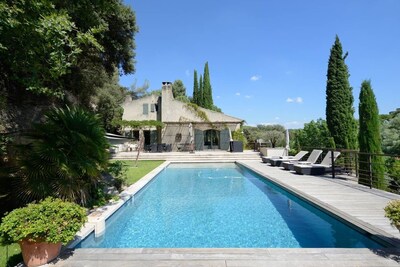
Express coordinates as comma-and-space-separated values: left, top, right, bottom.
78, 163, 382, 248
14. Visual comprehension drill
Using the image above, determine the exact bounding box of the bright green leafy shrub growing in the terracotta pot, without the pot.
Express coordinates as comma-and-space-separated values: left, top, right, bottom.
0, 197, 87, 244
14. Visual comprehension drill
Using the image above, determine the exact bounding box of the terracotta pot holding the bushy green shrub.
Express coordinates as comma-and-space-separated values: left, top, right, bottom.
19, 239, 61, 267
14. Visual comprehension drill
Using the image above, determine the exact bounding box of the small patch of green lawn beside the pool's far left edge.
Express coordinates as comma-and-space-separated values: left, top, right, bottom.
115, 160, 164, 186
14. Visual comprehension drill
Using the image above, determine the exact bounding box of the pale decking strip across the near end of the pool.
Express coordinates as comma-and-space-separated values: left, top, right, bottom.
54, 248, 399, 267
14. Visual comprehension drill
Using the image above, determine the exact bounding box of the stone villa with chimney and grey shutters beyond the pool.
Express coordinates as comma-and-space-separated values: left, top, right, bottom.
122, 82, 244, 151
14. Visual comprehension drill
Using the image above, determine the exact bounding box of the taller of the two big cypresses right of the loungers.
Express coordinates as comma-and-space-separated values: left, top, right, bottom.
326, 35, 357, 149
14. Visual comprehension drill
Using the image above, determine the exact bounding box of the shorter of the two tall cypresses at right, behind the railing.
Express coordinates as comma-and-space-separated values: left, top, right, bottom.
358, 81, 385, 189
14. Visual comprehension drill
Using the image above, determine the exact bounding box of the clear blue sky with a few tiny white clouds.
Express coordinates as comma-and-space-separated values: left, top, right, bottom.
120, 0, 400, 128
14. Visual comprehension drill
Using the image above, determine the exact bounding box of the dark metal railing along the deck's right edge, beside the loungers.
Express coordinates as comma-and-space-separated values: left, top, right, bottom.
307, 148, 400, 194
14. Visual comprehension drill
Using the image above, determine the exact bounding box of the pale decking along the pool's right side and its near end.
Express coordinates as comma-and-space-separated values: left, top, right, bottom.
48, 157, 400, 267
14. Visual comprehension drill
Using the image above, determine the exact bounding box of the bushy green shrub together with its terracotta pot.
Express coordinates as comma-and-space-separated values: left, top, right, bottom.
0, 197, 87, 267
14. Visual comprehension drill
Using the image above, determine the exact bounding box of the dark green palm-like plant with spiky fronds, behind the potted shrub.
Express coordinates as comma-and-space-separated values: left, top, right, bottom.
18, 107, 108, 205
